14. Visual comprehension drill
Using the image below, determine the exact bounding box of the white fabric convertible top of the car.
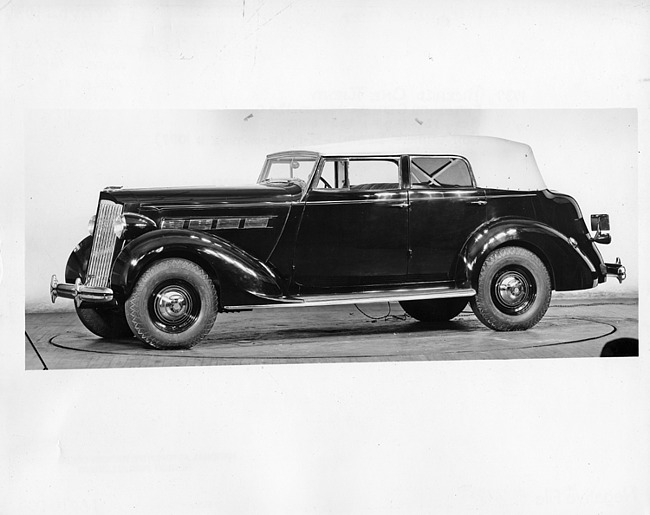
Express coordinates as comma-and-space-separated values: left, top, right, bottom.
278, 136, 546, 191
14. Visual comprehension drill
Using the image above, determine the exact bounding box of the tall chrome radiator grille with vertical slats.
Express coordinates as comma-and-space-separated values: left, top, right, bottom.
86, 200, 122, 288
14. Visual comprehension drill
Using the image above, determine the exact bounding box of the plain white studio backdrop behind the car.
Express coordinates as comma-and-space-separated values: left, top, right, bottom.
25, 109, 638, 311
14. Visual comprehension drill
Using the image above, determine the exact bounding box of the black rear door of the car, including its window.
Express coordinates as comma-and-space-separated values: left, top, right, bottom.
408, 156, 486, 282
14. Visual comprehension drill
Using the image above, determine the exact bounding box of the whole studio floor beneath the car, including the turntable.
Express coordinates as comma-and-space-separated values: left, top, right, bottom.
25, 296, 638, 370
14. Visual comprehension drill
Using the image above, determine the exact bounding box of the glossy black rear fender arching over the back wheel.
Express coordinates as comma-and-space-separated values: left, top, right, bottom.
456, 218, 597, 291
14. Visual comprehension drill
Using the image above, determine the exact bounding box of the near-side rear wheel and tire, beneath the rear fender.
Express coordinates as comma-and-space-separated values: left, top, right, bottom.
471, 247, 551, 331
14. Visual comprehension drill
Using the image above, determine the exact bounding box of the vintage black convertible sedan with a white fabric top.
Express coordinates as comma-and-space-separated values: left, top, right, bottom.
50, 137, 625, 348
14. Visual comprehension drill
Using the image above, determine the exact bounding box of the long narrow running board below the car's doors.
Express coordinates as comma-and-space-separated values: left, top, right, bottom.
224, 286, 476, 311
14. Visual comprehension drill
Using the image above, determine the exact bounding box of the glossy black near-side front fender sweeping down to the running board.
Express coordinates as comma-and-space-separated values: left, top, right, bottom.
111, 229, 283, 304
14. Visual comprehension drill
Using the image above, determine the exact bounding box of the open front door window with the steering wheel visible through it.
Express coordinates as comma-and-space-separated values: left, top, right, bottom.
315, 158, 400, 190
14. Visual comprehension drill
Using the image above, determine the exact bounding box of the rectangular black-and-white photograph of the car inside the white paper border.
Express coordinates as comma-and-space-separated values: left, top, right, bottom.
25, 110, 638, 369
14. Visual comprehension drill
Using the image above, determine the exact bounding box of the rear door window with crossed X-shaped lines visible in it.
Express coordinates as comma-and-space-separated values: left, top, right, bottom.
411, 157, 472, 188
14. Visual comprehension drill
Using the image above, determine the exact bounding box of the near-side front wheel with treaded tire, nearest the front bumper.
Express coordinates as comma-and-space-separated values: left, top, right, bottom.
126, 258, 218, 349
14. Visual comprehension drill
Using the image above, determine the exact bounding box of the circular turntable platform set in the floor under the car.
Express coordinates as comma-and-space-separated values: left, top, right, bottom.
50, 305, 616, 364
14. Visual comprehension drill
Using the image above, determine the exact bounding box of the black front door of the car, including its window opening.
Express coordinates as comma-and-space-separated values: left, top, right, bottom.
293, 156, 408, 293
